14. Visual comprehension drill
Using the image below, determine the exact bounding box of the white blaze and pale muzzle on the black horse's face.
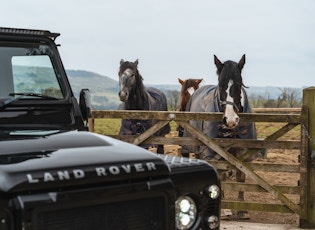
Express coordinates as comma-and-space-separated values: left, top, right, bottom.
224, 80, 239, 129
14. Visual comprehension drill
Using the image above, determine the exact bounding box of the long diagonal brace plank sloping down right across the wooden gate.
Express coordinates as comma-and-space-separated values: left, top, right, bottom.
179, 122, 300, 214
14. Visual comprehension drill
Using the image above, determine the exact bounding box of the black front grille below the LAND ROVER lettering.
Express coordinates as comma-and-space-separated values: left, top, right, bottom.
36, 197, 167, 230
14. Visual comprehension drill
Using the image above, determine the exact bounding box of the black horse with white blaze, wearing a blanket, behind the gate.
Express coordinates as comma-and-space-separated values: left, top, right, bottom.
182, 54, 256, 218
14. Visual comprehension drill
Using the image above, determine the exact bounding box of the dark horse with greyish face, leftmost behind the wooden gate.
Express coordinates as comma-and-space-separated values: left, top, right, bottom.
118, 59, 170, 154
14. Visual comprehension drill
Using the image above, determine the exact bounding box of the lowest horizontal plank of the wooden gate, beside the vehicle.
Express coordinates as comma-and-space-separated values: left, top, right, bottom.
221, 200, 294, 213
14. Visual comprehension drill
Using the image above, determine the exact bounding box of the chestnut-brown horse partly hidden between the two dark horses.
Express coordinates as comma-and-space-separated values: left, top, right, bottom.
177, 78, 203, 140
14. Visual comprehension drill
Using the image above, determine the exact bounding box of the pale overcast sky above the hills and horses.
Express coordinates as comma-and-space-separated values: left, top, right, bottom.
0, 0, 315, 87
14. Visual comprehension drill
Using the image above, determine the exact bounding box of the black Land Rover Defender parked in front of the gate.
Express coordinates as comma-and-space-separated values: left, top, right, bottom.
0, 28, 220, 230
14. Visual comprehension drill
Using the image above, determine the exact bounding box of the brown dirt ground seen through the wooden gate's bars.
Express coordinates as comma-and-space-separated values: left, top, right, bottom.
152, 130, 300, 229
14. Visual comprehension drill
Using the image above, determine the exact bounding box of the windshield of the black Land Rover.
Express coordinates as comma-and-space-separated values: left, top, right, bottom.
0, 43, 63, 99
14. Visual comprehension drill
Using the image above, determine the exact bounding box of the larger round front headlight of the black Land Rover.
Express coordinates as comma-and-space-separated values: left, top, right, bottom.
175, 196, 197, 230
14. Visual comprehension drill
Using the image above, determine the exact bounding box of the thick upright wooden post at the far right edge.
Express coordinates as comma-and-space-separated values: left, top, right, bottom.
300, 87, 315, 228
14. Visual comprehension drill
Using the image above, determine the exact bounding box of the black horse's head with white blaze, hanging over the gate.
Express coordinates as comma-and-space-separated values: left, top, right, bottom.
214, 54, 245, 129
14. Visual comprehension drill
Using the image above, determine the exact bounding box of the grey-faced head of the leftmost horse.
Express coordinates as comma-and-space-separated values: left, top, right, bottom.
118, 59, 143, 102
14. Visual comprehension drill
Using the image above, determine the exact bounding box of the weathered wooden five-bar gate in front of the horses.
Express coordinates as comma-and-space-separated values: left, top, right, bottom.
90, 87, 315, 227
